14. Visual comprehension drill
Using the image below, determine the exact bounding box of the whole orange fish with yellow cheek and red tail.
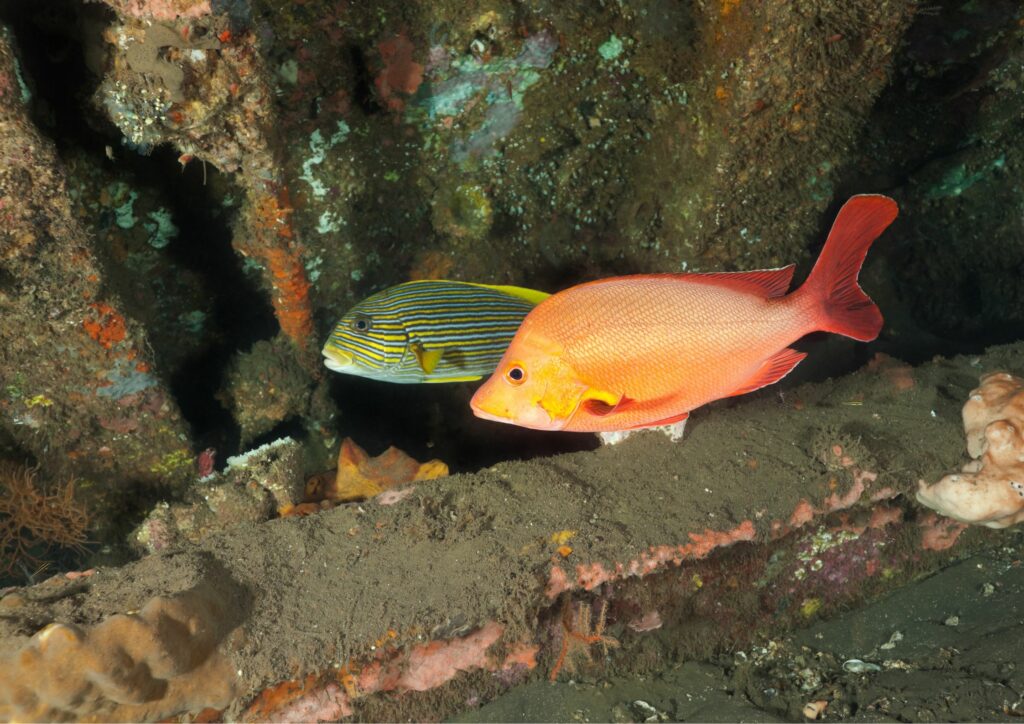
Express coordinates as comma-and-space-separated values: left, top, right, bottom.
471, 196, 897, 432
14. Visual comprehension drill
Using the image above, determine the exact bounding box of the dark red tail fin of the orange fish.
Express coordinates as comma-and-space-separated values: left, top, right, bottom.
800, 194, 899, 342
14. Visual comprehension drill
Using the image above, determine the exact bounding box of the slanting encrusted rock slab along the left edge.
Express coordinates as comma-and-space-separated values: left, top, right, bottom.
0, 35, 193, 511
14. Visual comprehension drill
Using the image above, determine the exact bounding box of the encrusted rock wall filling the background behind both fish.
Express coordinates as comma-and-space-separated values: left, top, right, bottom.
0, 0, 1024, 577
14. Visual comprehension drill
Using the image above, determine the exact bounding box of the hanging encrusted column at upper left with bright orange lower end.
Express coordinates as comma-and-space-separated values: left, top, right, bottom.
95, 0, 314, 367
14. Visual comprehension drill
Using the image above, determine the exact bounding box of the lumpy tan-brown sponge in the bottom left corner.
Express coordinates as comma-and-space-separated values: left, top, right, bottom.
0, 589, 237, 721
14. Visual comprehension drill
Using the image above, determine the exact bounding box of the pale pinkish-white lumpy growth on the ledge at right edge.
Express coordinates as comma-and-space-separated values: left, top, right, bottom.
918, 372, 1024, 528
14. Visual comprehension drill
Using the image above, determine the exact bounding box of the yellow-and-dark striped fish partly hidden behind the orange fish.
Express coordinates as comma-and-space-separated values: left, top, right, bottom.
324, 280, 549, 383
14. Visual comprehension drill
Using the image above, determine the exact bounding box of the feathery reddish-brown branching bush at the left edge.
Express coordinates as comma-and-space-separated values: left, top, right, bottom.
0, 461, 89, 573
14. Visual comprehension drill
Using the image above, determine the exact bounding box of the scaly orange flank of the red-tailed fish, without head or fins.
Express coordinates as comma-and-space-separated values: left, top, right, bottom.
529, 276, 811, 429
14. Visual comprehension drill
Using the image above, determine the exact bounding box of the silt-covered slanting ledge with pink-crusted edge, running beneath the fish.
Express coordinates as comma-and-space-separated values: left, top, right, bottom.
0, 344, 1024, 721
